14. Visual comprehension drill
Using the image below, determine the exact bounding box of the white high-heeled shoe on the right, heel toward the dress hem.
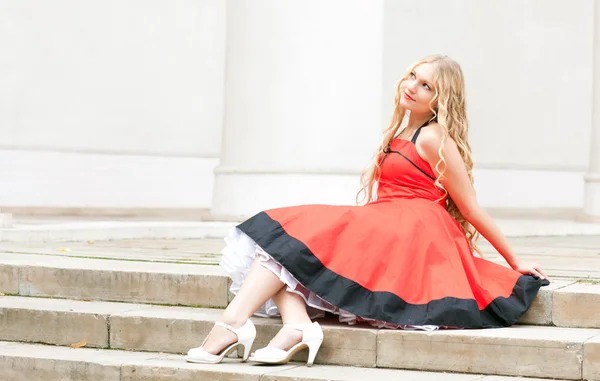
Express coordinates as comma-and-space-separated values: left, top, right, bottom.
250, 322, 323, 366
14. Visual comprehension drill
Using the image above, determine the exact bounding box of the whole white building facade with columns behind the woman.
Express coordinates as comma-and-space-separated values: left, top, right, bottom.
0, 0, 600, 219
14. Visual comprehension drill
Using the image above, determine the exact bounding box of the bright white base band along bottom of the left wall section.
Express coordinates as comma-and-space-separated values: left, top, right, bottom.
0, 150, 218, 210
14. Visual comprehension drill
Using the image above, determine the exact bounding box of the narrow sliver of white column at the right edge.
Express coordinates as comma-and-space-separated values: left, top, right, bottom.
584, 1, 600, 221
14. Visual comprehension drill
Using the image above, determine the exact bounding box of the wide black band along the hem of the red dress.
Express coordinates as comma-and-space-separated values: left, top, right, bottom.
238, 212, 548, 328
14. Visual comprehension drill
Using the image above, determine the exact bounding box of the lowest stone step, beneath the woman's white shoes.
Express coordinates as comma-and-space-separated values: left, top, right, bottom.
0, 342, 576, 381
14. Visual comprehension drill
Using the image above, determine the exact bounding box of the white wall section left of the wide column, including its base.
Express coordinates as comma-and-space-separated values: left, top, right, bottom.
0, 0, 225, 208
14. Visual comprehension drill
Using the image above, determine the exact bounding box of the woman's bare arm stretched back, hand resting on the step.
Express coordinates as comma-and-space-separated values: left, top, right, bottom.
417, 124, 547, 279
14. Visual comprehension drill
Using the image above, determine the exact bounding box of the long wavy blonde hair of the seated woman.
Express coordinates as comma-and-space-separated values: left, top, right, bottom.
356, 55, 482, 255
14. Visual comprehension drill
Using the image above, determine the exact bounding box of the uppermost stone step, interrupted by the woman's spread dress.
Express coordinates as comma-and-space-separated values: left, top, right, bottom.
0, 253, 600, 328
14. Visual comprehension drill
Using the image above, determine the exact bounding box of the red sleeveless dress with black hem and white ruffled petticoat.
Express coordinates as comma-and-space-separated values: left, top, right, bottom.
221, 129, 548, 328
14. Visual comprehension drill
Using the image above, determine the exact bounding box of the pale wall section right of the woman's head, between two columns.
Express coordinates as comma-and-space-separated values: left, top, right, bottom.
383, 0, 593, 207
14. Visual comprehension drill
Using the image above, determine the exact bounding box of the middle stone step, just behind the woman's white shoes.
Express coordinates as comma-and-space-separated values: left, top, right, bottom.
0, 296, 600, 380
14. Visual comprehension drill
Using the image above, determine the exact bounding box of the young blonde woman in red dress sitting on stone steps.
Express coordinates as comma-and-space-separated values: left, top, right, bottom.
187, 56, 548, 365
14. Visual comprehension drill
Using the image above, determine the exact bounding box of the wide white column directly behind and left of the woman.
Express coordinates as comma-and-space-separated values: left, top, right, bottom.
211, 0, 384, 219
